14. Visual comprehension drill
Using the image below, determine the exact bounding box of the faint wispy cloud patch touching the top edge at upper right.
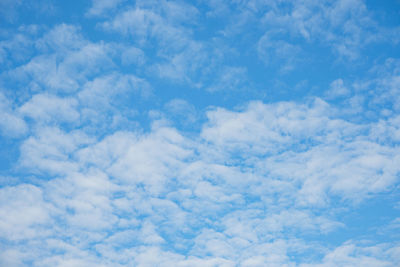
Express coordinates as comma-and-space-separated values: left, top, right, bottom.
263, 0, 386, 59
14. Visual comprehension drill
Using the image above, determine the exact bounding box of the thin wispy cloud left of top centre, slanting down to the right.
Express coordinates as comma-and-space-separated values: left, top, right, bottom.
101, 1, 223, 87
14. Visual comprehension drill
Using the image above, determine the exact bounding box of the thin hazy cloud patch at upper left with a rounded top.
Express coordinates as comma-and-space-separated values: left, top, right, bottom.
6, 24, 114, 93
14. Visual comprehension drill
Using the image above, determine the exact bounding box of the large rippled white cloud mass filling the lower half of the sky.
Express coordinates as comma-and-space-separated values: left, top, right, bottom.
1, 99, 399, 266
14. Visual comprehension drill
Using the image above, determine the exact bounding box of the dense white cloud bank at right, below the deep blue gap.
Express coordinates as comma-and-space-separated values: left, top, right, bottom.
202, 101, 400, 206
